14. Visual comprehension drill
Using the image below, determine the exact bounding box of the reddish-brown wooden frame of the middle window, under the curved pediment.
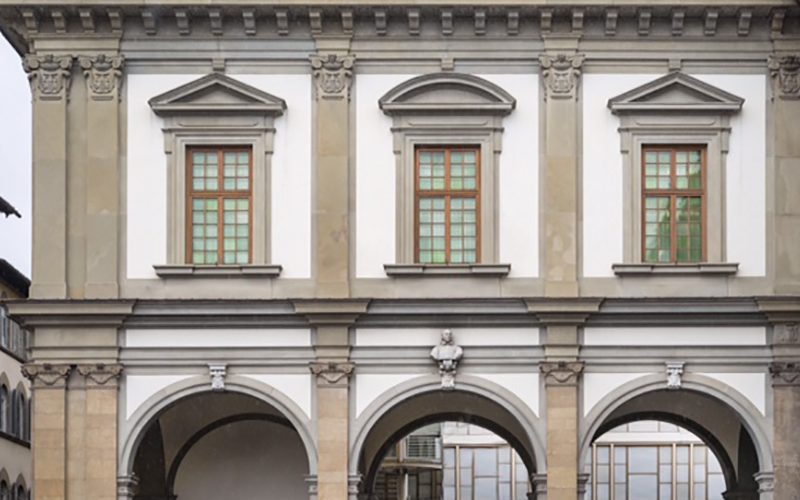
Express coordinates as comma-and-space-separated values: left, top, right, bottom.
414, 144, 482, 265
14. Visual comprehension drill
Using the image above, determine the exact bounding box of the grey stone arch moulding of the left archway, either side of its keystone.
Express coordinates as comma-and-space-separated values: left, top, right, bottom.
118, 375, 317, 476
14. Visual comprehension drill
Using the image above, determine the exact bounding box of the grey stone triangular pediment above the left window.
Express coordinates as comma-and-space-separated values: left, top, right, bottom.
149, 73, 286, 116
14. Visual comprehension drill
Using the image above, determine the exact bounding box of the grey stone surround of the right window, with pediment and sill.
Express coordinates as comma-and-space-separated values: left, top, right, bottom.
609, 73, 744, 276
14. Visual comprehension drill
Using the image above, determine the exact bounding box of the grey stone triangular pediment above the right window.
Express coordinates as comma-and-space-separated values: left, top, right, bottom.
608, 71, 744, 114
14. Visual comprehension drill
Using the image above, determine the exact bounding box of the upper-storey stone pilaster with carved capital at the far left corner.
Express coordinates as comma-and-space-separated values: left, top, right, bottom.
23, 54, 73, 299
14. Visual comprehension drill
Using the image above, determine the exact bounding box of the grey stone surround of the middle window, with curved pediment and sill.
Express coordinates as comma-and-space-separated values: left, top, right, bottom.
379, 73, 515, 277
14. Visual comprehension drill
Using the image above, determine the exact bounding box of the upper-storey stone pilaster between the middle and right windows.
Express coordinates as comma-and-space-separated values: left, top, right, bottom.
539, 44, 584, 297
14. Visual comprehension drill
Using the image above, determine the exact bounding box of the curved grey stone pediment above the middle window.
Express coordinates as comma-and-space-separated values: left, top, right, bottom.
378, 73, 516, 115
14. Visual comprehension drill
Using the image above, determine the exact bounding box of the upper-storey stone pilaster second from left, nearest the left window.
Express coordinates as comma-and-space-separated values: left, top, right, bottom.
79, 53, 123, 299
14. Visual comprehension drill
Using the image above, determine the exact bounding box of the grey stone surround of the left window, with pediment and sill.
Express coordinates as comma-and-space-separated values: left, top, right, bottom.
150, 74, 286, 278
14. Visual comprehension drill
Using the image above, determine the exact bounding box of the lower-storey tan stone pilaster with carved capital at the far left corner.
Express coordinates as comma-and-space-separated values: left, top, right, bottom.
22, 363, 72, 500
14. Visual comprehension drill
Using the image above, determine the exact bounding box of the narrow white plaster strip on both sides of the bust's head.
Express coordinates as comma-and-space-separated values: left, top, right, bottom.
355, 328, 539, 347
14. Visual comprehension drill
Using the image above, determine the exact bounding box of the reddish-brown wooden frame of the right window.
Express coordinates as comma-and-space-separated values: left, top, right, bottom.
640, 144, 708, 264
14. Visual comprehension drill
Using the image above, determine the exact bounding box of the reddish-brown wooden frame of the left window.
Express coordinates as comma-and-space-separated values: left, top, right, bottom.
185, 145, 254, 267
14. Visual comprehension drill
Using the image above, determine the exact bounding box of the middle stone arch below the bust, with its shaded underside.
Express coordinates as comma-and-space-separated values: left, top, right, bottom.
349, 375, 546, 487
